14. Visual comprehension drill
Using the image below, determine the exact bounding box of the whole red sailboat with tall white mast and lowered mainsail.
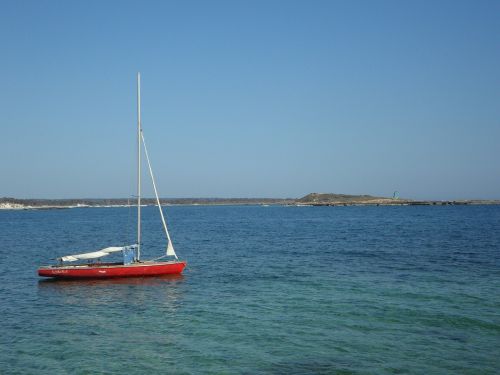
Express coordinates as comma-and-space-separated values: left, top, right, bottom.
38, 73, 186, 279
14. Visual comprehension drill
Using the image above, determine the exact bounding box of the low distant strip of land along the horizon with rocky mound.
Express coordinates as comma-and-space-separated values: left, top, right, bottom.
0, 193, 500, 210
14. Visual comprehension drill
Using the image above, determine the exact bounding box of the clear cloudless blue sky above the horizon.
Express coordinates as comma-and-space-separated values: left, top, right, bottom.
0, 0, 500, 199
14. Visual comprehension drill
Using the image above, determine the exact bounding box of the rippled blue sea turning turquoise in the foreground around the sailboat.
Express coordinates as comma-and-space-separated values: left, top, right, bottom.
0, 206, 500, 374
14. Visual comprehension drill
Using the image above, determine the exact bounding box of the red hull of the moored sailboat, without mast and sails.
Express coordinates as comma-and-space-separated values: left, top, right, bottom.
38, 261, 186, 279
